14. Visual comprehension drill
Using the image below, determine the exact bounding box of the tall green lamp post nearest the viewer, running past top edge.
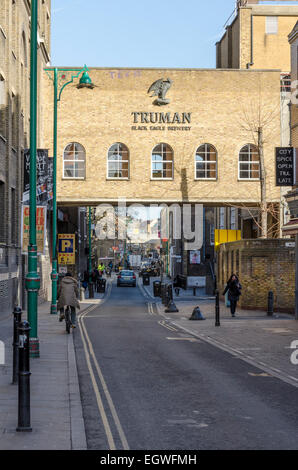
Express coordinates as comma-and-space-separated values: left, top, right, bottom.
25, 0, 40, 357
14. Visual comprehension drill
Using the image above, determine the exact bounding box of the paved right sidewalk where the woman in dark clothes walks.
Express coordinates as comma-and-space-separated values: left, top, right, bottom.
139, 278, 298, 387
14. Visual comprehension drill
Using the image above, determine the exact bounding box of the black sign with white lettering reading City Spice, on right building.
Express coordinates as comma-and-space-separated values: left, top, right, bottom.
275, 147, 295, 186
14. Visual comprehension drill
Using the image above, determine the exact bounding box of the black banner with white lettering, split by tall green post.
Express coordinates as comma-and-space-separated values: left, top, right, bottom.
23, 149, 53, 205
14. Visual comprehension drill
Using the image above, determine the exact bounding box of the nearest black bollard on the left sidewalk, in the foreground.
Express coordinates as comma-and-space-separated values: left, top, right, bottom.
16, 321, 32, 432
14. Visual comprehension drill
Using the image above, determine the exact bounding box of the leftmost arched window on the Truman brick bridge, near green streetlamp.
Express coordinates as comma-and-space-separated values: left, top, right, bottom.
63, 142, 86, 179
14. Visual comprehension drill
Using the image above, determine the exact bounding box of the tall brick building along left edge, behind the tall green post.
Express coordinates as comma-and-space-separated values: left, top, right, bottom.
0, 0, 51, 314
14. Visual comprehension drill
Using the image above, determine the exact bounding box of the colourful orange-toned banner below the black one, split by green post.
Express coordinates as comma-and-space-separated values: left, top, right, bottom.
22, 205, 47, 255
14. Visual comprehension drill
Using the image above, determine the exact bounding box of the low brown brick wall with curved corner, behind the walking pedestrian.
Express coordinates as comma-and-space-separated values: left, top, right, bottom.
217, 239, 295, 313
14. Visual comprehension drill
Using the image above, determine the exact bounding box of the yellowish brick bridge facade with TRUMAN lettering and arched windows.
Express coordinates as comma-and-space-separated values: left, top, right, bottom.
43, 68, 280, 206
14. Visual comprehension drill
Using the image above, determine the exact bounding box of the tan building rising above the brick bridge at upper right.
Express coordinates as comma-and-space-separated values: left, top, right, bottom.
216, 0, 298, 73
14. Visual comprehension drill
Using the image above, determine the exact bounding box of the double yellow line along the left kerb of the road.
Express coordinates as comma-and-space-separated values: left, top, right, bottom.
78, 280, 129, 450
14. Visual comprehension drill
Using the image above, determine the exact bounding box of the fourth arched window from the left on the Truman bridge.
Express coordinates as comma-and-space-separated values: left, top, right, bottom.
195, 144, 217, 180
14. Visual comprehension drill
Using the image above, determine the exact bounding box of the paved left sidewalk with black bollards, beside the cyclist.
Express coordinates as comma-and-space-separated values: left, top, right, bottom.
0, 284, 108, 450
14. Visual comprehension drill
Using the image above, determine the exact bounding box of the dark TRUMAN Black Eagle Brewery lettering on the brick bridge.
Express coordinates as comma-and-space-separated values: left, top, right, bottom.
131, 111, 192, 131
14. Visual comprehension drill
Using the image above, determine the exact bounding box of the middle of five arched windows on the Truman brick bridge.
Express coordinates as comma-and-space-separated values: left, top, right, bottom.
151, 144, 174, 179
